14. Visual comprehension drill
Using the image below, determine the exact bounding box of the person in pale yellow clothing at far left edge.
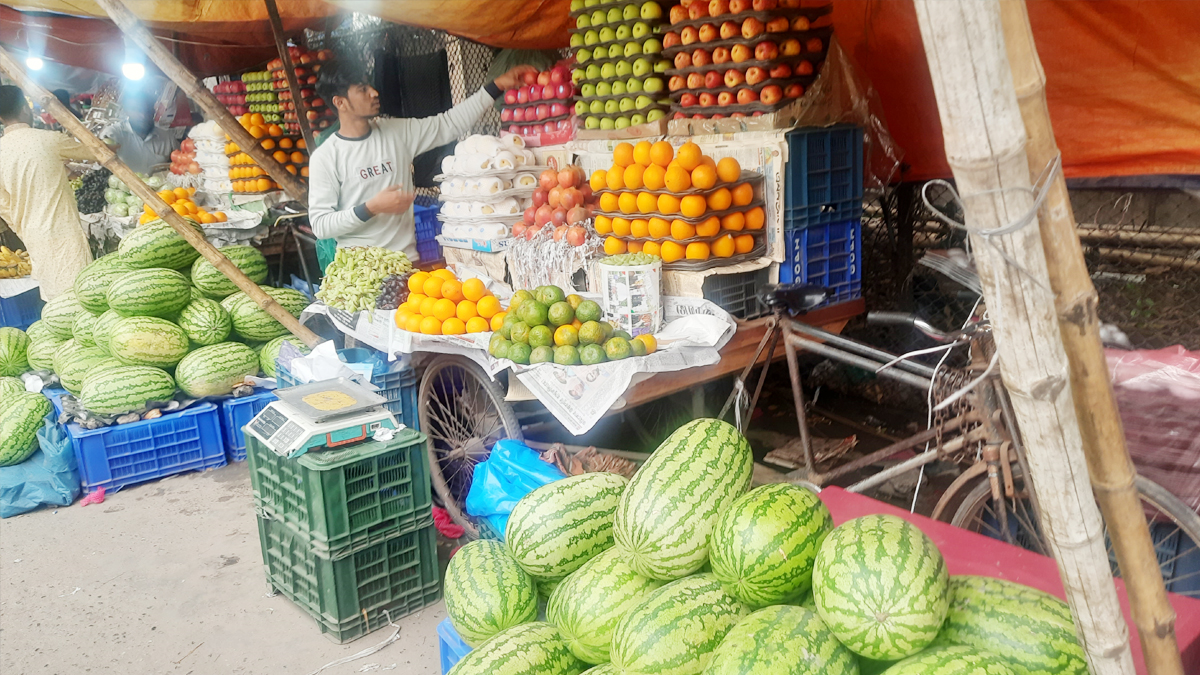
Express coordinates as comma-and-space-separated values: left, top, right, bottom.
0, 85, 94, 300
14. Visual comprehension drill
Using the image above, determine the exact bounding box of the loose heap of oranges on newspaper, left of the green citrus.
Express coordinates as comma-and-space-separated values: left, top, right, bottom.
396, 269, 506, 335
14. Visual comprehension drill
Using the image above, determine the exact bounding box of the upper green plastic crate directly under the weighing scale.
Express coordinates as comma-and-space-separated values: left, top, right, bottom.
246, 429, 432, 558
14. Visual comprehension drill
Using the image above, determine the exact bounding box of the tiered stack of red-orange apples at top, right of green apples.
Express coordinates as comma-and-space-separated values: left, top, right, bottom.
662, 0, 833, 119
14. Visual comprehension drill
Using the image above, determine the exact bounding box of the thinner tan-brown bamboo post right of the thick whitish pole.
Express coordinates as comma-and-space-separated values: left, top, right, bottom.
1000, 0, 1183, 675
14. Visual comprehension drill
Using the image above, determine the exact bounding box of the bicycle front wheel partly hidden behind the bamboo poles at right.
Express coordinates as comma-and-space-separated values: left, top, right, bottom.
950, 466, 1200, 598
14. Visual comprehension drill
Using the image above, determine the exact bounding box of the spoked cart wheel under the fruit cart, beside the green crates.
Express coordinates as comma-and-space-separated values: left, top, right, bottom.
418, 356, 524, 539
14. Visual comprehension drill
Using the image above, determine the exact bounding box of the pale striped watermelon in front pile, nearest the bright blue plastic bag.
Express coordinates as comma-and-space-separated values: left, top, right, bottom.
504, 472, 628, 579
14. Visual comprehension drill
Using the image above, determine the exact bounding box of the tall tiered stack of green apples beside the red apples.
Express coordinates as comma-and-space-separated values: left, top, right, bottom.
571, 0, 671, 130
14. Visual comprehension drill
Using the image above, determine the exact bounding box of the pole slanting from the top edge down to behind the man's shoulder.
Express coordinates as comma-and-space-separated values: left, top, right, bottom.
96, 0, 312, 203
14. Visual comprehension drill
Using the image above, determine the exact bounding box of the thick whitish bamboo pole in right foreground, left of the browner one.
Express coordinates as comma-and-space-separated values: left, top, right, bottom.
914, 0, 1134, 675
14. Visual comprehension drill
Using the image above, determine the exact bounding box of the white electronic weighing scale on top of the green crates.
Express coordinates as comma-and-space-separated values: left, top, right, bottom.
246, 377, 400, 458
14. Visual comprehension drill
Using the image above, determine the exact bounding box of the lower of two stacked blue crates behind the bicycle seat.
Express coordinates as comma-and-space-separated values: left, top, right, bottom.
779, 220, 863, 305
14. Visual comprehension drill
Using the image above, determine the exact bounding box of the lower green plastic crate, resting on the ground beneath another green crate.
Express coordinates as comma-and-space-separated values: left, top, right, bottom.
258, 515, 442, 644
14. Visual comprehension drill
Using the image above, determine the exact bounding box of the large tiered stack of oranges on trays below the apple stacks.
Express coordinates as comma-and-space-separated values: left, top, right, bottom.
589, 141, 767, 263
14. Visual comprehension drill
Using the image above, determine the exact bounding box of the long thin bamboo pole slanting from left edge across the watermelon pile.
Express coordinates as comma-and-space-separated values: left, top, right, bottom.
0, 47, 322, 347
